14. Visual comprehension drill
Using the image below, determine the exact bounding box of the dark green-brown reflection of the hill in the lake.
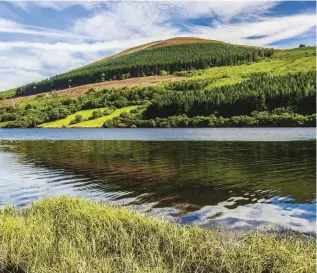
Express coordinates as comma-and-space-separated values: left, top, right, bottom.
2, 141, 315, 209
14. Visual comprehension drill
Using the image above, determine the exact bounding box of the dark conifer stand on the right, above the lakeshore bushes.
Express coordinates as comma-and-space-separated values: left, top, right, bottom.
144, 71, 316, 119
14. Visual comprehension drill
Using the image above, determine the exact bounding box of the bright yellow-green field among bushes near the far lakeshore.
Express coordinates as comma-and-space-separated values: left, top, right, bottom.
39, 106, 137, 128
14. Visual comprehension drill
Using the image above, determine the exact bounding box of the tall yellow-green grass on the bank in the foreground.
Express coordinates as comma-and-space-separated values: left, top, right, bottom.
0, 197, 316, 273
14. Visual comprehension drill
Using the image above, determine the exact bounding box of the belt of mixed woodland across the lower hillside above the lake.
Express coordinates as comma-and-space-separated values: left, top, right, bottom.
0, 67, 316, 127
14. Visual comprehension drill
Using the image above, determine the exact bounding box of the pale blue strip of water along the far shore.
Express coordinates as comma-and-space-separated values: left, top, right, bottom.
0, 128, 316, 141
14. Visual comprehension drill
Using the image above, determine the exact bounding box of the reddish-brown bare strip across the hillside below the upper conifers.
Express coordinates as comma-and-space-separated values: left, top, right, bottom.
0, 75, 183, 106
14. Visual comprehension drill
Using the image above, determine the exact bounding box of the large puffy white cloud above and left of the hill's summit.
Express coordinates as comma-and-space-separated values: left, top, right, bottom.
73, 2, 180, 41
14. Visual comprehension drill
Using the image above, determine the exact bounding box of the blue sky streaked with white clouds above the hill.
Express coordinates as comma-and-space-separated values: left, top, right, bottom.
0, 0, 316, 91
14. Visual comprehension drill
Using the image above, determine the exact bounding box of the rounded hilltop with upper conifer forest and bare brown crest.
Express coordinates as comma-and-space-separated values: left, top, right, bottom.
12, 38, 273, 96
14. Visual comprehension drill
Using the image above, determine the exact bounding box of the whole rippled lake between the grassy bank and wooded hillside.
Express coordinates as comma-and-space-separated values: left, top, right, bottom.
0, 128, 316, 233
